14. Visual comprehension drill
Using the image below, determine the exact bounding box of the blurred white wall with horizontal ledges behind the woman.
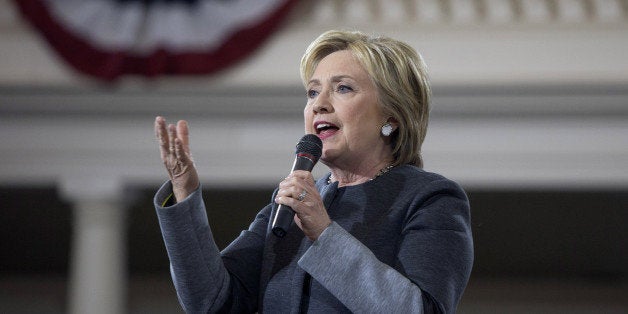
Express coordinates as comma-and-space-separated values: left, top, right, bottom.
0, 0, 628, 188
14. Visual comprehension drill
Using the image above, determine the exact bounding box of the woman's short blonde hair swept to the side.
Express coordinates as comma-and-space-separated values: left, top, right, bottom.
301, 30, 431, 167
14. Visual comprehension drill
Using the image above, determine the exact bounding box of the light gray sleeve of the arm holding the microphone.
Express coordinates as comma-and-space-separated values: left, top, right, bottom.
298, 222, 423, 313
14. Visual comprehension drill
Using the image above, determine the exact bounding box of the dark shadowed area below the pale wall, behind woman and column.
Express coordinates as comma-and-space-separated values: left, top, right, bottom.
0, 187, 628, 313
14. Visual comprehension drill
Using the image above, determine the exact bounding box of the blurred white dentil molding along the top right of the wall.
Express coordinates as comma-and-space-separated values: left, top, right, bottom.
295, 0, 628, 26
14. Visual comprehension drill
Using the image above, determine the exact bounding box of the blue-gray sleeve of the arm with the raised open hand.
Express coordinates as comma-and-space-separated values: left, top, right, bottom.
154, 182, 230, 313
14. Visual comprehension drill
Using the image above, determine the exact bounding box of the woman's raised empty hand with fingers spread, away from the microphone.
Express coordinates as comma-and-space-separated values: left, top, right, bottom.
155, 117, 199, 201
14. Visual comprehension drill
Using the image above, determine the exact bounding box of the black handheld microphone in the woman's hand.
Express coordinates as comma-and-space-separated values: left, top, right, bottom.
272, 134, 323, 238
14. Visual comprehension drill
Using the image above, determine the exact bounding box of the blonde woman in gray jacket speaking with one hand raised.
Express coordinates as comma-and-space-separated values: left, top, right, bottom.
154, 31, 473, 313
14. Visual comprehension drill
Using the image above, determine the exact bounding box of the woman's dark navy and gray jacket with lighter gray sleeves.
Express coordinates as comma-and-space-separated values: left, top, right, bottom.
154, 165, 473, 313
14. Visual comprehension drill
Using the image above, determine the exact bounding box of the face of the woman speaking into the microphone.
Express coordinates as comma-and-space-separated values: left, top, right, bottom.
304, 50, 390, 167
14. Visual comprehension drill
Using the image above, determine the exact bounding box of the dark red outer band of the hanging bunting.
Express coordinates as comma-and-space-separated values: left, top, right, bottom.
15, 0, 297, 82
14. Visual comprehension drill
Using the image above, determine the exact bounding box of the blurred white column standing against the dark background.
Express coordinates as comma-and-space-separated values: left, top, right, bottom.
61, 177, 127, 314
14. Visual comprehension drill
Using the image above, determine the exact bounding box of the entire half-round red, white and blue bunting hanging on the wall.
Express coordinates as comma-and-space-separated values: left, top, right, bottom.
14, 0, 296, 81
